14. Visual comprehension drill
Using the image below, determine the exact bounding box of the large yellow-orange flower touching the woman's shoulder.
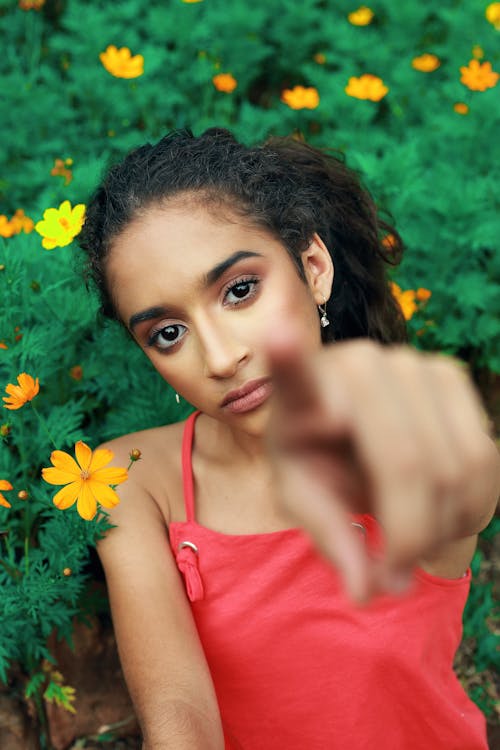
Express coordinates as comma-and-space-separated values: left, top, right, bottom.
42, 440, 128, 521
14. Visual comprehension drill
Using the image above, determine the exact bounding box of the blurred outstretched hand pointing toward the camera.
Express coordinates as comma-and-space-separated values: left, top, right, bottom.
268, 333, 500, 601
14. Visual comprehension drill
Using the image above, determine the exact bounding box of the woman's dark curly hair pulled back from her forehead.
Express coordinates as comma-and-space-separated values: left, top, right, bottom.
79, 128, 406, 343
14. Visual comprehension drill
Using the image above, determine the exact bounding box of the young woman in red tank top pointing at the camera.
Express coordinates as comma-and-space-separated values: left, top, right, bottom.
81, 129, 500, 750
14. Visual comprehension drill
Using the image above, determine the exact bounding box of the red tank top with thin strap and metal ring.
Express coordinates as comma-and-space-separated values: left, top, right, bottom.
169, 413, 488, 750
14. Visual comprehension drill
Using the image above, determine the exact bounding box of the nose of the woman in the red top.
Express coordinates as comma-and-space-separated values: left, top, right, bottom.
198, 324, 248, 378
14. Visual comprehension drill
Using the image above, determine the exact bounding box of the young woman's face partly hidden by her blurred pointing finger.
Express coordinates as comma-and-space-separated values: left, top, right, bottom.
107, 204, 328, 433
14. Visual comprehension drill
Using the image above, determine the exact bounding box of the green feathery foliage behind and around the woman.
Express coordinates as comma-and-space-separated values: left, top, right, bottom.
0, 0, 500, 740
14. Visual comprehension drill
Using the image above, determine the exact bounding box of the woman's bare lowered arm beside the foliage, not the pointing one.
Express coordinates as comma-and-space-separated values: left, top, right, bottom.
98, 452, 224, 750
